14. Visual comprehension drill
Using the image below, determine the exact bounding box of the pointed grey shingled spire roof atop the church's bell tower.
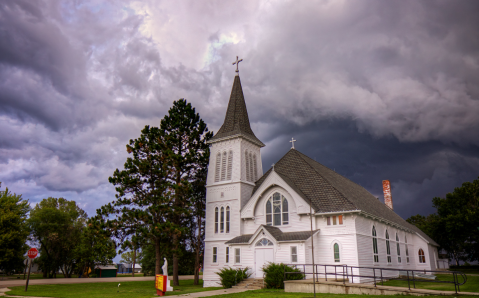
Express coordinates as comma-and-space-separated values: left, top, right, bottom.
209, 76, 264, 147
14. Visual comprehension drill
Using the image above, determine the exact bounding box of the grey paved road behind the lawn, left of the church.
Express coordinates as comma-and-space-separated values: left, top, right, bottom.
0, 275, 203, 289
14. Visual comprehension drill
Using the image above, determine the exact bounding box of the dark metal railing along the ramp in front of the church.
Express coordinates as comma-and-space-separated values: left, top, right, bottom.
283, 264, 467, 294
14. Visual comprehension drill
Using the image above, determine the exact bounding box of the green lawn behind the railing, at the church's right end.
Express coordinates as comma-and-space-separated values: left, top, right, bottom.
384, 274, 479, 295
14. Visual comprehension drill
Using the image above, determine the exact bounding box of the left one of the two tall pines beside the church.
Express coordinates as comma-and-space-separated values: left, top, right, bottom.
105, 126, 177, 274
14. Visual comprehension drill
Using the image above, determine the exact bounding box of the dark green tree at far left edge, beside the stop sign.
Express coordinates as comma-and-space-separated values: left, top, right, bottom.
0, 183, 30, 274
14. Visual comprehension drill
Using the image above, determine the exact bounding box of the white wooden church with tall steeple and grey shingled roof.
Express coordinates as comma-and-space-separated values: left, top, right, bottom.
203, 66, 438, 287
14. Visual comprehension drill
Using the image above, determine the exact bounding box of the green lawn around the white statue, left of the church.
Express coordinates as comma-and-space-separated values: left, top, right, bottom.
7, 280, 221, 298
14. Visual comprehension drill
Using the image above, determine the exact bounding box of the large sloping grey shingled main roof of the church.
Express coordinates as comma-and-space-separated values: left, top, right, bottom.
253, 149, 437, 245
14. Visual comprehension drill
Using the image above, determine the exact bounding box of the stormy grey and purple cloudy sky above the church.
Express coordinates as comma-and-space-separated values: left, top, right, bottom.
0, 0, 479, 218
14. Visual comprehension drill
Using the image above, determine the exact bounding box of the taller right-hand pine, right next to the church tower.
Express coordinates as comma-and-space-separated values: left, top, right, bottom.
160, 99, 212, 286
